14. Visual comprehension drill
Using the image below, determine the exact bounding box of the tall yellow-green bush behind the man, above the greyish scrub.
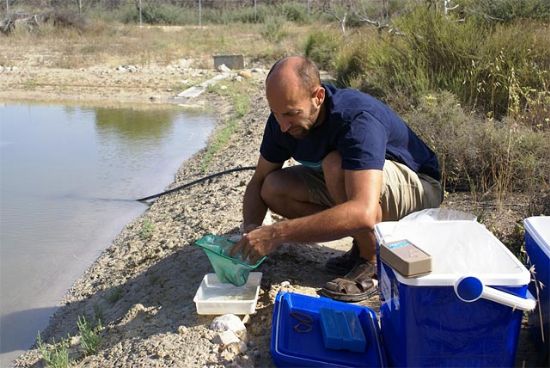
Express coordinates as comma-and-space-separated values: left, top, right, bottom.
337, 7, 550, 118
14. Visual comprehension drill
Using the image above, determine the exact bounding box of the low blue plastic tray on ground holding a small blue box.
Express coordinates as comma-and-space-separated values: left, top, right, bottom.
271, 291, 387, 367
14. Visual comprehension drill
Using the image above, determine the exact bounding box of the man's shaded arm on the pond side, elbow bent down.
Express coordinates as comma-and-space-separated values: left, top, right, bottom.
243, 155, 283, 231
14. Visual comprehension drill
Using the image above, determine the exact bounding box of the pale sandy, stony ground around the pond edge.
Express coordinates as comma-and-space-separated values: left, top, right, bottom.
4, 61, 535, 367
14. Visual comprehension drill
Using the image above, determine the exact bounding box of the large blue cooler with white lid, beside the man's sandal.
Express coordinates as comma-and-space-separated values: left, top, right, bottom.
375, 221, 536, 367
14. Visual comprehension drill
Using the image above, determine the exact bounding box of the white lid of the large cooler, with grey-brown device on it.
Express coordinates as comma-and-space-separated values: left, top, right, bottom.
375, 221, 530, 286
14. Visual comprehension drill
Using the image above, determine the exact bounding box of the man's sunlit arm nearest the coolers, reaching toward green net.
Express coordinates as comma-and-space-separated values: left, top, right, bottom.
235, 170, 383, 260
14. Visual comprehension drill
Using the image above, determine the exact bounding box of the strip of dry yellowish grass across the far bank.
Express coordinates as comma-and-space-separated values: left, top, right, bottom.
0, 21, 312, 69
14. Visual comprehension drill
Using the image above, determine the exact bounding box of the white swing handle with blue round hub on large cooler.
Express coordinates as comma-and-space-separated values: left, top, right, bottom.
454, 276, 537, 311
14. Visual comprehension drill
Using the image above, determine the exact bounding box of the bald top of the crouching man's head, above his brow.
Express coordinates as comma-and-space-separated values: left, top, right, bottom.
266, 56, 321, 94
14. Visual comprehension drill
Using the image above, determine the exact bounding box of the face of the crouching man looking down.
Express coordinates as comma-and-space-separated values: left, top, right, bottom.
267, 87, 324, 139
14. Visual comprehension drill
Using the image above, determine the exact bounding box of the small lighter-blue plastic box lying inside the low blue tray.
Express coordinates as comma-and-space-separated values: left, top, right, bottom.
319, 308, 367, 353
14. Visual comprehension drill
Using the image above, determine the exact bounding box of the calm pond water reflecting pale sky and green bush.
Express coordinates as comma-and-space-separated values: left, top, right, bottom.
0, 104, 215, 367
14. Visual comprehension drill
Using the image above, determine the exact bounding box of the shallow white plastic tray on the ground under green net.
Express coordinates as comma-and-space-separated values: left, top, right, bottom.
193, 272, 262, 314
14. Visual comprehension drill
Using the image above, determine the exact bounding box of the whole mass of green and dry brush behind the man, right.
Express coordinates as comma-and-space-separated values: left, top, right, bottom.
306, 0, 550, 203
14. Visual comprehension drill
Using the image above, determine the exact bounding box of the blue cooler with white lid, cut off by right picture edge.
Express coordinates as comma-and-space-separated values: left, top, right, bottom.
523, 216, 550, 362
